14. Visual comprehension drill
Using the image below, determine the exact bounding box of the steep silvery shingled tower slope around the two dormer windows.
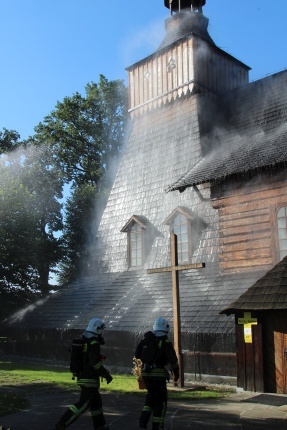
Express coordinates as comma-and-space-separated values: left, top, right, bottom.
95, 96, 220, 272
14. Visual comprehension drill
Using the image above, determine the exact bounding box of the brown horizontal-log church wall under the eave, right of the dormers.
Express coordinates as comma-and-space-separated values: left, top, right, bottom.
212, 171, 287, 271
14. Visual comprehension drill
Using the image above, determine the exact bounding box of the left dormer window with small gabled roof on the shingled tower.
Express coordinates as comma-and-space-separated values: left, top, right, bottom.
121, 215, 158, 268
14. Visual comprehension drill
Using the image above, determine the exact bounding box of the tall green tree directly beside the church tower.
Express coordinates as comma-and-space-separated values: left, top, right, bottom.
32, 75, 127, 283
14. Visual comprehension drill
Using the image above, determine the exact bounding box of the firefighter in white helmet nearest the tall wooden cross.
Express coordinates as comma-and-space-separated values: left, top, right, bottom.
134, 317, 179, 430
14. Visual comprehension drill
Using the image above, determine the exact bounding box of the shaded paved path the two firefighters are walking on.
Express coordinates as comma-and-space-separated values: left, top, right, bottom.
0, 385, 287, 430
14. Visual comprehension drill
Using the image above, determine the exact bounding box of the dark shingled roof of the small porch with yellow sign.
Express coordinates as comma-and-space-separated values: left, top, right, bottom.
220, 257, 287, 315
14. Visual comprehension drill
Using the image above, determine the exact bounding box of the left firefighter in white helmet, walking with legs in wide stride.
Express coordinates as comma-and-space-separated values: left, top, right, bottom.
54, 318, 113, 430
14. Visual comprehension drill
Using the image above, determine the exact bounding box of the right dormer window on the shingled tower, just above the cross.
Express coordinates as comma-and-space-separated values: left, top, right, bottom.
164, 206, 205, 264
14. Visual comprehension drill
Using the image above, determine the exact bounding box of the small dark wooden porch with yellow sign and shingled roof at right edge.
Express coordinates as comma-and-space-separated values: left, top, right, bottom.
222, 257, 287, 394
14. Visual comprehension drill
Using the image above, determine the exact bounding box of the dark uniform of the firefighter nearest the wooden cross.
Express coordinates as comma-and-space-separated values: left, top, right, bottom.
135, 318, 179, 430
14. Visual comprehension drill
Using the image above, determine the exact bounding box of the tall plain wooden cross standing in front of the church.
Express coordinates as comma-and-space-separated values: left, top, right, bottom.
147, 232, 205, 388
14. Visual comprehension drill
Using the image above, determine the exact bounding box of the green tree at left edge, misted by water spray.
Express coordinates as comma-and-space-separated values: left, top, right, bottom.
0, 146, 62, 316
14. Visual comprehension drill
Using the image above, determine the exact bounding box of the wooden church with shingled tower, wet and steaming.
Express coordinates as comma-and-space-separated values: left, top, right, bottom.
5, 0, 287, 392
